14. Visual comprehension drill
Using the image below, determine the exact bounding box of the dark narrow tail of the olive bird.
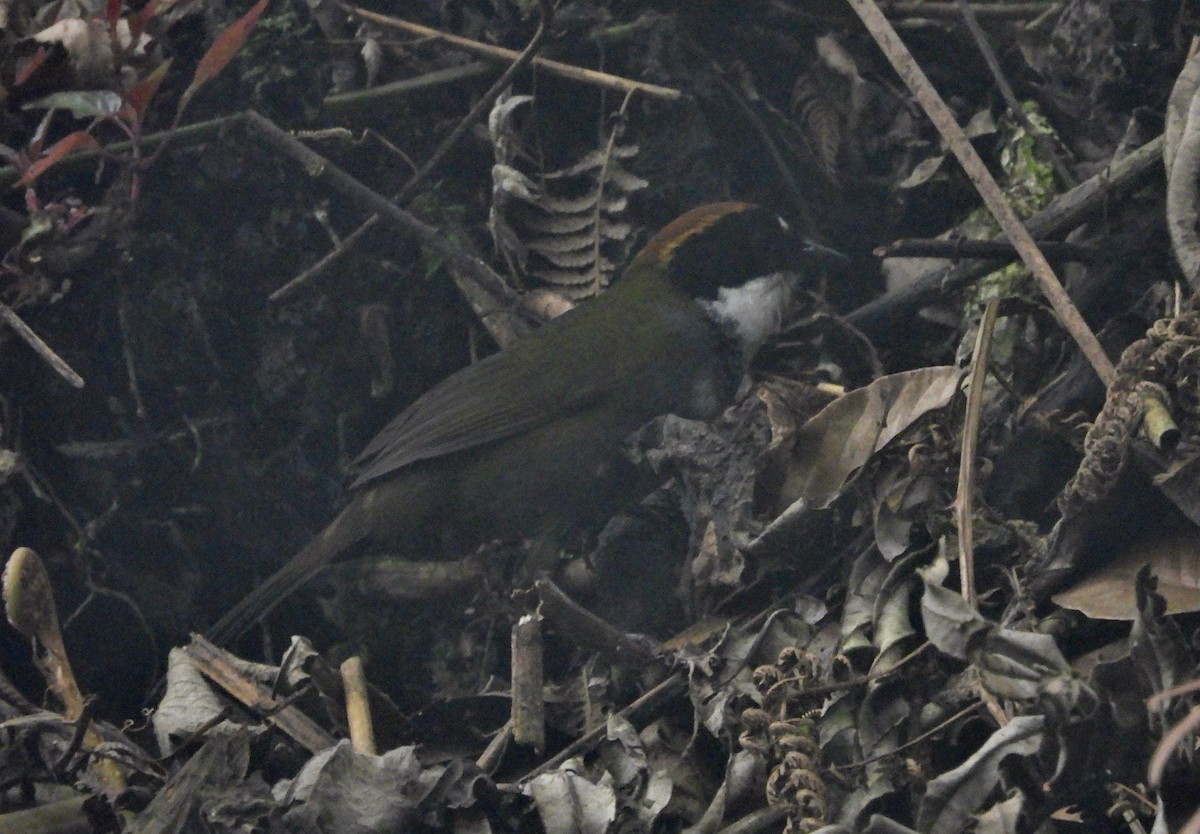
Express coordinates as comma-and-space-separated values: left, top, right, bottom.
205, 502, 361, 644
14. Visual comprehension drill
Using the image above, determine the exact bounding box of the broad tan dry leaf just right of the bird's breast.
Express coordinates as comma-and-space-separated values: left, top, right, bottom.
780, 365, 962, 508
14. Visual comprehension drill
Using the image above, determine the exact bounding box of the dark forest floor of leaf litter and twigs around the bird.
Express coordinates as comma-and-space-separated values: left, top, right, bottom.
0, 0, 1200, 834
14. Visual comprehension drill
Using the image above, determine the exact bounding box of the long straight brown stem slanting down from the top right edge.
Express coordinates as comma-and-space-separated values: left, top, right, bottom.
848, 0, 1116, 385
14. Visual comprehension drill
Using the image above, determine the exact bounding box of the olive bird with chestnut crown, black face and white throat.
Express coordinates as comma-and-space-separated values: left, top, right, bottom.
208, 202, 842, 643
